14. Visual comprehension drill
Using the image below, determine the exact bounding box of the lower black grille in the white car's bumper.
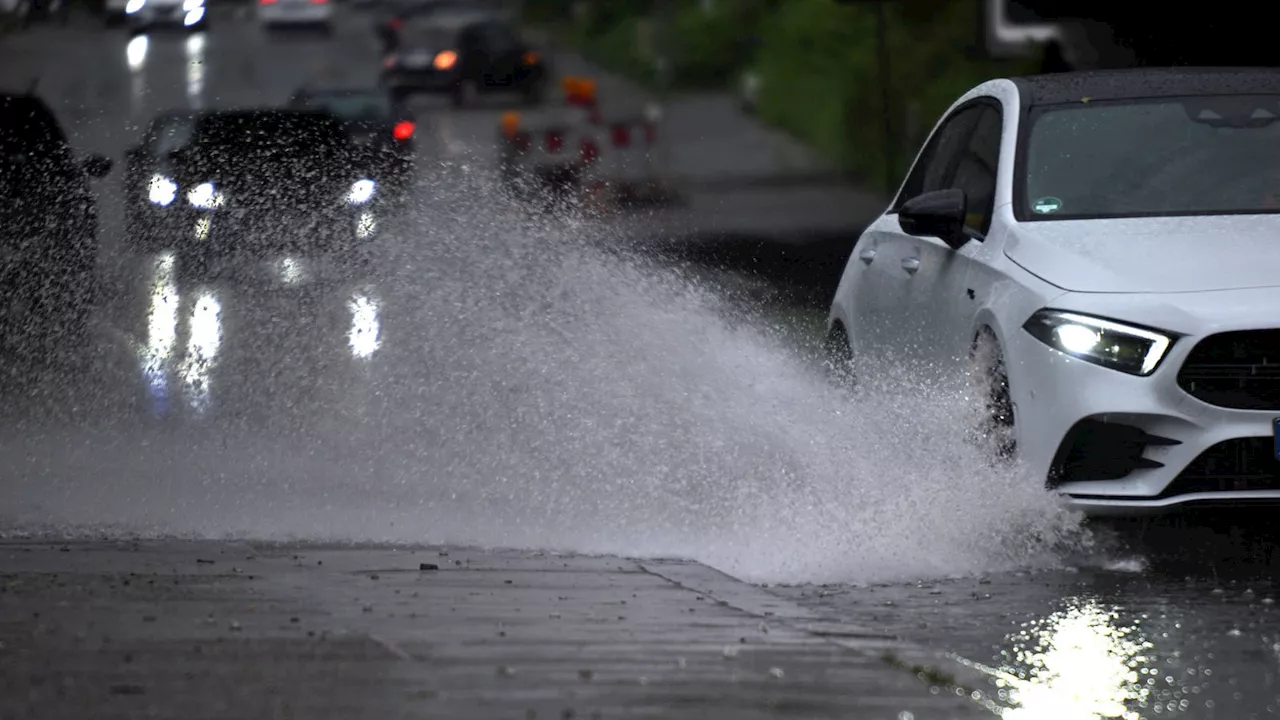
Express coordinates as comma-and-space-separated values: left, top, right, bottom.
1158, 437, 1280, 497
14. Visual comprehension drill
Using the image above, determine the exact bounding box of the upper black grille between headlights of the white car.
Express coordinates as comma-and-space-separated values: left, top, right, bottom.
1178, 329, 1280, 410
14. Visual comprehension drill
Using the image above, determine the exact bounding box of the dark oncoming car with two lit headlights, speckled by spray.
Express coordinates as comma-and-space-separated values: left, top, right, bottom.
133, 109, 383, 265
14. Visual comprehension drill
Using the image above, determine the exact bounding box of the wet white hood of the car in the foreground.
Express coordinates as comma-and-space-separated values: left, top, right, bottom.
1005, 215, 1280, 293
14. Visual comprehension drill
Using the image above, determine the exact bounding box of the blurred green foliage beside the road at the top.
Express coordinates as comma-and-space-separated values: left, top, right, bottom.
535, 0, 1039, 191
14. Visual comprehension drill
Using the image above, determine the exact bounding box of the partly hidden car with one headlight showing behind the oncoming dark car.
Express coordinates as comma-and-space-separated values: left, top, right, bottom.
124, 110, 202, 251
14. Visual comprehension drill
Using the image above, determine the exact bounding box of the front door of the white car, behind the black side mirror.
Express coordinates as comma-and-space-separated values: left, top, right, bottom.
908, 100, 1004, 366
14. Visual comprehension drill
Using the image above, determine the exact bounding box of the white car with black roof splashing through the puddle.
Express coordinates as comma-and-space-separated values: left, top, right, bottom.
828, 69, 1280, 515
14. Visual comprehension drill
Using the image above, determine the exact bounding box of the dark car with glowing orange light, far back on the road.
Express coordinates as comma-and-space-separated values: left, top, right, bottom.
381, 12, 550, 106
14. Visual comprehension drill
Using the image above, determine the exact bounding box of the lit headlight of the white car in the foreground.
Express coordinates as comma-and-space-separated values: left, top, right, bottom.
1023, 310, 1176, 375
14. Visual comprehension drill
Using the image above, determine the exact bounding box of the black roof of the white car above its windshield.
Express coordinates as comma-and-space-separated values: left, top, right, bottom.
1012, 68, 1280, 108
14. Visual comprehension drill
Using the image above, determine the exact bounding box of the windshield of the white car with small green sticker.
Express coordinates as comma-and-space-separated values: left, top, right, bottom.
1016, 95, 1280, 220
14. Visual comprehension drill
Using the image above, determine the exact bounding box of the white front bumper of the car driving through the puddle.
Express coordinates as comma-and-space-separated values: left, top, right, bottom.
1004, 283, 1280, 515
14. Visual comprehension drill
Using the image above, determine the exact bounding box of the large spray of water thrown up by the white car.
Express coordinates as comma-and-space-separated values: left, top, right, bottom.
0, 170, 1078, 582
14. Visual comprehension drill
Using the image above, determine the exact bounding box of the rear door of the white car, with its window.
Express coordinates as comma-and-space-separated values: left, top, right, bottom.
850, 105, 982, 357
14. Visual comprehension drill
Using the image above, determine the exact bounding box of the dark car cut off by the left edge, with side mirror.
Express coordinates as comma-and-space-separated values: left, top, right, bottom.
0, 94, 111, 347
